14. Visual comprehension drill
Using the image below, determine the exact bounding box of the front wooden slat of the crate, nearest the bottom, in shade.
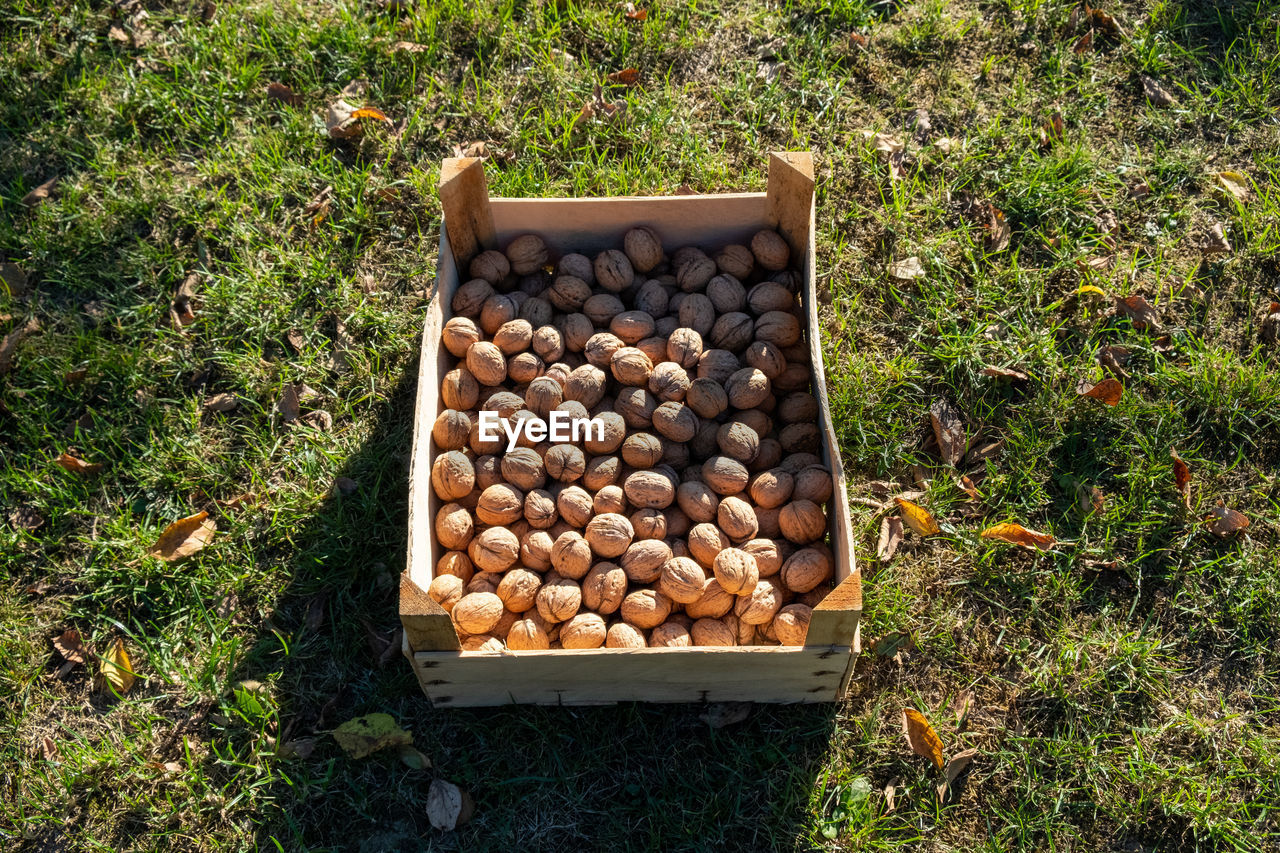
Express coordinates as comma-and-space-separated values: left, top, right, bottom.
412, 647, 849, 708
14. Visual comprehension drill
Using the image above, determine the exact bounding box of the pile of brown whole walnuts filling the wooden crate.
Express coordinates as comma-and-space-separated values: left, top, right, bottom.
429, 227, 833, 651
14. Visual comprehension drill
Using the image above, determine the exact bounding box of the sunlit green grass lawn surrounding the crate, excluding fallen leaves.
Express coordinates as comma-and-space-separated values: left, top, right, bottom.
0, 0, 1280, 850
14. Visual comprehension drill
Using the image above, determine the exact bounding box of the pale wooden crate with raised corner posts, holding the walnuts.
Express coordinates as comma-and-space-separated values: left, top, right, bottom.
401, 152, 861, 707
